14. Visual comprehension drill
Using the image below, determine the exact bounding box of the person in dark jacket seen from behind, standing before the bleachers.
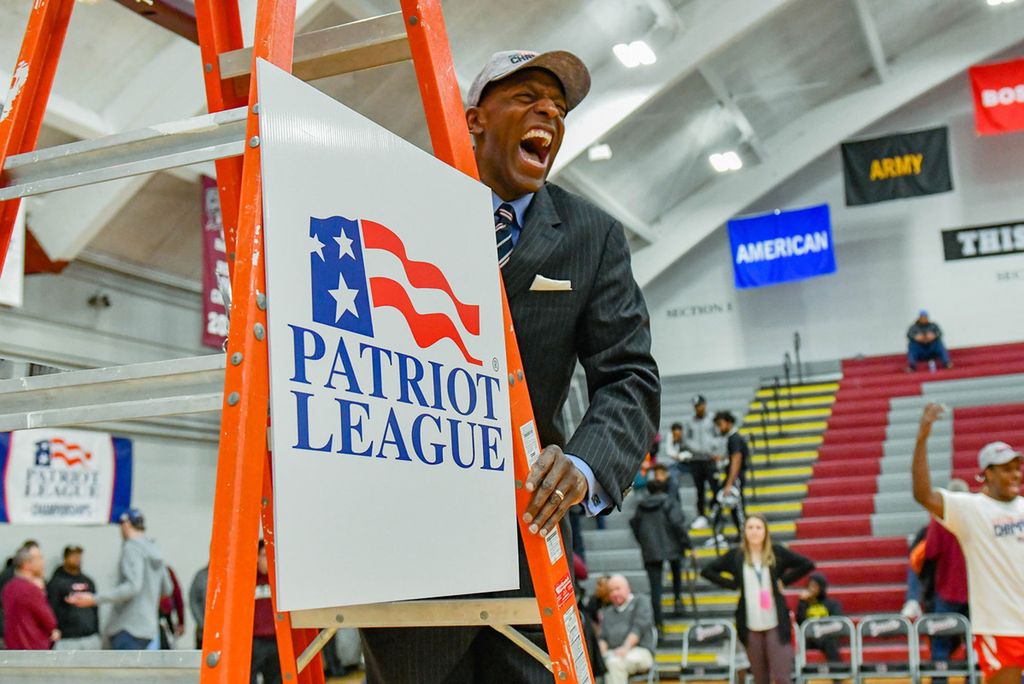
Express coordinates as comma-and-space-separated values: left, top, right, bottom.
630, 479, 690, 630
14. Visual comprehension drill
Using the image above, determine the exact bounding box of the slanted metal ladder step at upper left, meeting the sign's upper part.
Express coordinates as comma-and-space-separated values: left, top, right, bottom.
0, 106, 247, 202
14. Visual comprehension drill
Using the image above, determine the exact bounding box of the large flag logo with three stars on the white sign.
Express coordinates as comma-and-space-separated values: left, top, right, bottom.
309, 216, 482, 366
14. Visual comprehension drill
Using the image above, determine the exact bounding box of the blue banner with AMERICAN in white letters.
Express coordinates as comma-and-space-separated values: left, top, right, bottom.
729, 204, 836, 289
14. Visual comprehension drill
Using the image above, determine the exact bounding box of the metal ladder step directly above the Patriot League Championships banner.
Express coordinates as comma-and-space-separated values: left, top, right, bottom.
0, 354, 224, 430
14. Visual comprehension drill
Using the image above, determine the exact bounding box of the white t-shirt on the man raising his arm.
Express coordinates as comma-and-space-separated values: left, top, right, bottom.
939, 489, 1024, 637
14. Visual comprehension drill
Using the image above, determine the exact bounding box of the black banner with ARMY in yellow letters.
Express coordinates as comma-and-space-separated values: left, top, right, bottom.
842, 126, 953, 207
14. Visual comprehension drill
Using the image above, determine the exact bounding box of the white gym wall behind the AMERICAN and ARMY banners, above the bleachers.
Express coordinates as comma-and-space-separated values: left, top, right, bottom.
645, 75, 1024, 376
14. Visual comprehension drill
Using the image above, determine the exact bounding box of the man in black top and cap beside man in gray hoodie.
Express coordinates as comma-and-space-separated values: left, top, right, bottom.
46, 544, 103, 651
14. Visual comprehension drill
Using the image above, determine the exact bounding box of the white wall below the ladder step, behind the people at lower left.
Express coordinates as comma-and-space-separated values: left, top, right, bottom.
0, 438, 217, 648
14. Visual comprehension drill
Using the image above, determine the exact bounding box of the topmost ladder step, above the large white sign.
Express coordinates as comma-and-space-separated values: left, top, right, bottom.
219, 12, 412, 81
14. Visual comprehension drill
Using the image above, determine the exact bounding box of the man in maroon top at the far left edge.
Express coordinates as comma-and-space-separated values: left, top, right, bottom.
0, 546, 60, 650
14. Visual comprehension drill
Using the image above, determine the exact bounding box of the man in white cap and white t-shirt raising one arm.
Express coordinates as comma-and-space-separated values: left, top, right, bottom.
912, 403, 1024, 684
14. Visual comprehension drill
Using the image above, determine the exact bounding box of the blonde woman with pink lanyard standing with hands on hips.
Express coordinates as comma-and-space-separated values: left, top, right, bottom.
700, 514, 814, 684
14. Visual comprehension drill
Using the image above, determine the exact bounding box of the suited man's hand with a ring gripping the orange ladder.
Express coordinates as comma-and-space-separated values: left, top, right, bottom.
522, 444, 587, 535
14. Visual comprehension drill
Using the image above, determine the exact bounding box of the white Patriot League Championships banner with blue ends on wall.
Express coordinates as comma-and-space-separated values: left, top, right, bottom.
0, 428, 132, 525
